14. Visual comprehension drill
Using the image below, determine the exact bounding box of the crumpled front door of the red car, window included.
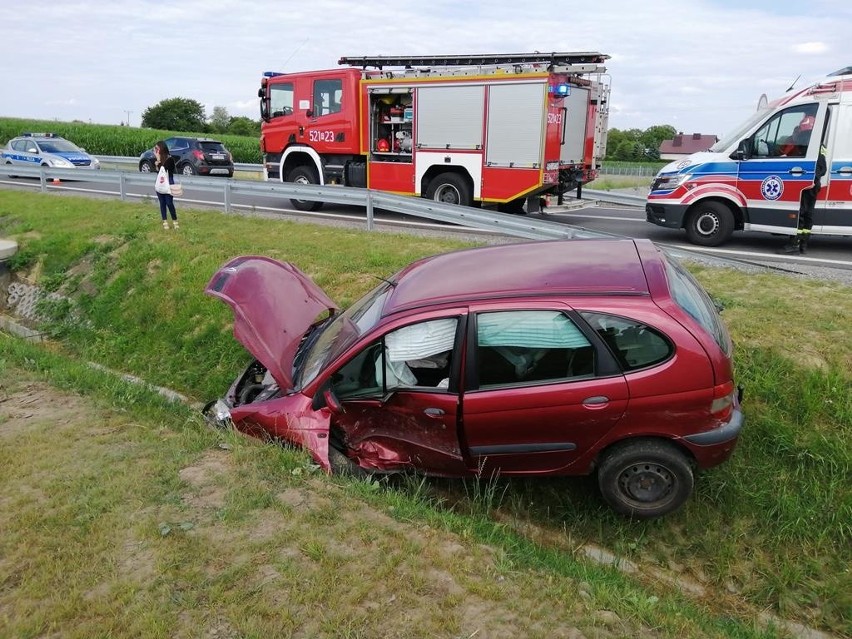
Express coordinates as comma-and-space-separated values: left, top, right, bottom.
331, 311, 467, 476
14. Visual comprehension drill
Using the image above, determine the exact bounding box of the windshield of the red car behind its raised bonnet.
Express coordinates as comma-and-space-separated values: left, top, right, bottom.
295, 282, 391, 388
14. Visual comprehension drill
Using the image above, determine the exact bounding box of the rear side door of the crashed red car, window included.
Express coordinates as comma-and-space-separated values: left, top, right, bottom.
462, 306, 629, 474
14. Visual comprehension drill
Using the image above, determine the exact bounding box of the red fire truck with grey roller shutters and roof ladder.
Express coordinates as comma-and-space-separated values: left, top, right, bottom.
258, 52, 610, 213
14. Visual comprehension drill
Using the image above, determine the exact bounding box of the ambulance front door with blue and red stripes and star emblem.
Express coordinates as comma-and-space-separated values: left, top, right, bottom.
737, 102, 825, 231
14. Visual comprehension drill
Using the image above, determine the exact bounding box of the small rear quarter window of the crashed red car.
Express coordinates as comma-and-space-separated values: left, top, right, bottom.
580, 311, 674, 371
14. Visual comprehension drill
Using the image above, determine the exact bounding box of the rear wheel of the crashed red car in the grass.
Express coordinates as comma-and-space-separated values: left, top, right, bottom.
598, 440, 695, 519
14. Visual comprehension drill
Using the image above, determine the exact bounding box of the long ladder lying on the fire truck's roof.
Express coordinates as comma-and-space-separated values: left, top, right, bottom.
337, 51, 609, 73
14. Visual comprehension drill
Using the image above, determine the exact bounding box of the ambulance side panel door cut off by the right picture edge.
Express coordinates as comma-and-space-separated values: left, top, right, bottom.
813, 104, 852, 235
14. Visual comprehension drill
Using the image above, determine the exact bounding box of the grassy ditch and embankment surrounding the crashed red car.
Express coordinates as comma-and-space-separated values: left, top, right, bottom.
0, 192, 852, 637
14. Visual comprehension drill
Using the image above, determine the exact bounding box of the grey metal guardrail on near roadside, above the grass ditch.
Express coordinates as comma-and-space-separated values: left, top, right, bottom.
0, 165, 617, 240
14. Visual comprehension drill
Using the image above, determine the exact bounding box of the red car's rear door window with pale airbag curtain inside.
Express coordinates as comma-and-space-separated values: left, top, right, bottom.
473, 310, 595, 387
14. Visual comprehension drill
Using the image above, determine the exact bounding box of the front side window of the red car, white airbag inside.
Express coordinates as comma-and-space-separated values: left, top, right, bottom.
332, 317, 458, 399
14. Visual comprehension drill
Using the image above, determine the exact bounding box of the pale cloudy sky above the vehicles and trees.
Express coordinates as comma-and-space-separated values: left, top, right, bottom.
0, 0, 852, 137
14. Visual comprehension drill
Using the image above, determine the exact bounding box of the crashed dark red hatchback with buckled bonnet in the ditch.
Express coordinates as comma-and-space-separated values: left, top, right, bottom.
204, 240, 743, 518
